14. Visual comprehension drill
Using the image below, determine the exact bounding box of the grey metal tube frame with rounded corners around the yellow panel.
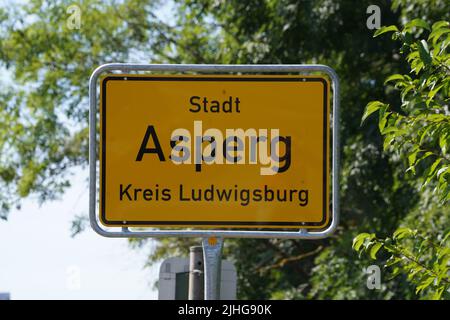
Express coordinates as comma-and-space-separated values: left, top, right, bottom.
89, 63, 339, 239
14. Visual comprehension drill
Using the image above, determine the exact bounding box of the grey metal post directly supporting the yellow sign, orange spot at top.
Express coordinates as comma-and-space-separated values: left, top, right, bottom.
203, 237, 223, 300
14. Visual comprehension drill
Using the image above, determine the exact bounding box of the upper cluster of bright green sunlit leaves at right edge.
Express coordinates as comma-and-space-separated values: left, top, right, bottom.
362, 19, 450, 203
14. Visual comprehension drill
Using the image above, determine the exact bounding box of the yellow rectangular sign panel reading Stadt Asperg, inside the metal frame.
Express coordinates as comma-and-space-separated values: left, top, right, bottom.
100, 74, 331, 229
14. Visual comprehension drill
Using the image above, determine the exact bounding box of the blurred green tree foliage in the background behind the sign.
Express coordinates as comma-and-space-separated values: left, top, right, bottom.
0, 0, 450, 299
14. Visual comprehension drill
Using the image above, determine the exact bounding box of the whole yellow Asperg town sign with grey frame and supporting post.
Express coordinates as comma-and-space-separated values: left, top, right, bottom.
89, 63, 340, 299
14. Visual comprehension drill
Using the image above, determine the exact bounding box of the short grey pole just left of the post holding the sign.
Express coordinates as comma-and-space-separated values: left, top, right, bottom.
188, 246, 204, 300
